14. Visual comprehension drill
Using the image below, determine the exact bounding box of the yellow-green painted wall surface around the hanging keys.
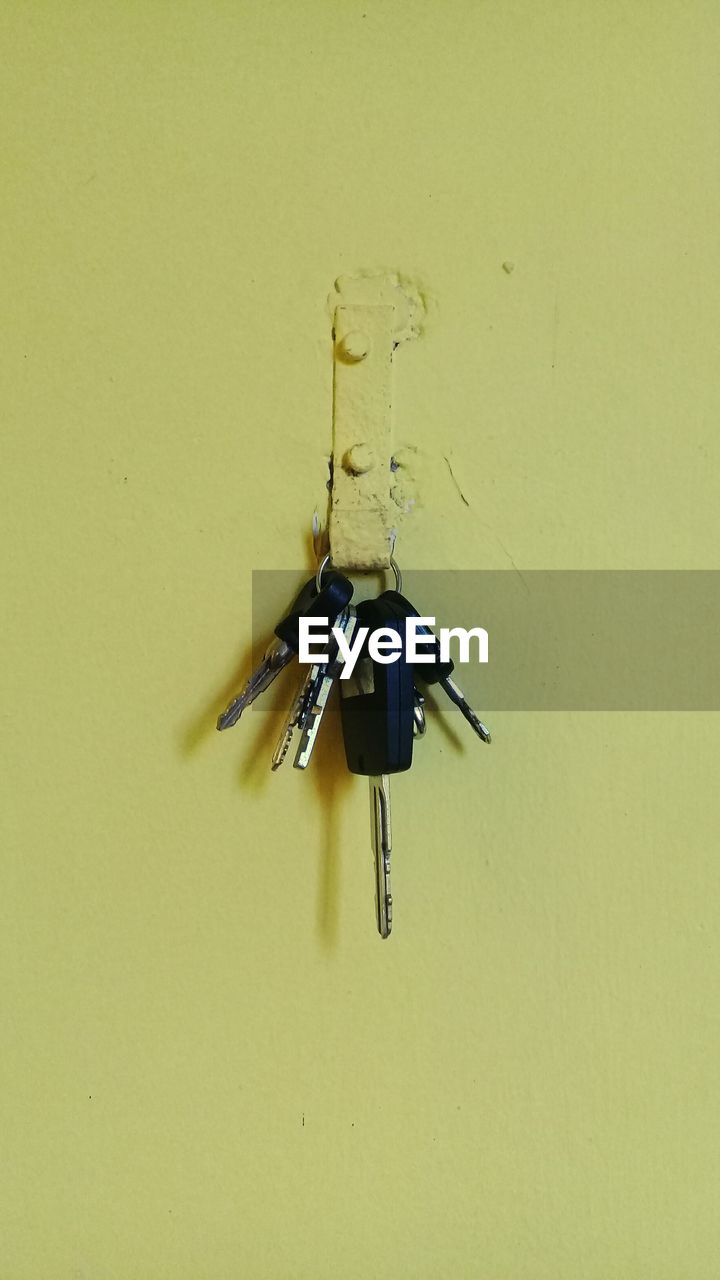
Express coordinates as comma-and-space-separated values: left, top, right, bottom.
0, 0, 720, 1280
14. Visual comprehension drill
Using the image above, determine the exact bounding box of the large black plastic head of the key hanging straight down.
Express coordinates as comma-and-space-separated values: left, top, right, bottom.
340, 598, 414, 777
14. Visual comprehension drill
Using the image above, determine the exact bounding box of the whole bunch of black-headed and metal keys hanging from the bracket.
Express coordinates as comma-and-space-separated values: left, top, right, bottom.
218, 556, 491, 938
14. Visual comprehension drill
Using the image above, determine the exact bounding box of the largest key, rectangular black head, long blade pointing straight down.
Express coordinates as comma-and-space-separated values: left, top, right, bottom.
340, 600, 415, 938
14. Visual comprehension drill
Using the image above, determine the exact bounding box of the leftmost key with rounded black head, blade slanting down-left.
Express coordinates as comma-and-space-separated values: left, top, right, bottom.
218, 571, 352, 730
